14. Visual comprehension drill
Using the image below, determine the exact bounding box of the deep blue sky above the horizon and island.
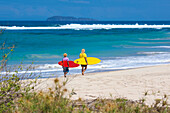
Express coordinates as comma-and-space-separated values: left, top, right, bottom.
0, 0, 170, 21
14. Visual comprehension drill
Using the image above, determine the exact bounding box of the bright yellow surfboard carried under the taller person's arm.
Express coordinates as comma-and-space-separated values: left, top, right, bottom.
74, 57, 101, 65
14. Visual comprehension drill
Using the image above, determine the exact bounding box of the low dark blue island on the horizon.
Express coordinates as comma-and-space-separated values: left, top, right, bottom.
47, 16, 98, 21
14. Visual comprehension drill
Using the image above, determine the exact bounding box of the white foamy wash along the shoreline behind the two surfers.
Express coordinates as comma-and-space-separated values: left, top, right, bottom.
1, 52, 170, 77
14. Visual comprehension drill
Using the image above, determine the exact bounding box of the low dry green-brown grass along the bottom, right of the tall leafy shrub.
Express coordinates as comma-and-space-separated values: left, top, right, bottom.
6, 78, 170, 113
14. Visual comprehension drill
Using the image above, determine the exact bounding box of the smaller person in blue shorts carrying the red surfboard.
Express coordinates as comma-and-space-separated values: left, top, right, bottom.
62, 53, 69, 77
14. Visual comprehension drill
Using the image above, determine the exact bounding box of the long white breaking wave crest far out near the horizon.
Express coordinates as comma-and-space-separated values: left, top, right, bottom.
0, 24, 170, 30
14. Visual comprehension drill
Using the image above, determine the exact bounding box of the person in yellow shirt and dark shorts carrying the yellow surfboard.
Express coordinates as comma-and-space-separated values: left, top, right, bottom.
79, 49, 88, 75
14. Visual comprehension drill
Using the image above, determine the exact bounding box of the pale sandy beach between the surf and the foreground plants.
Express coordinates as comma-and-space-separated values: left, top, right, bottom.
36, 64, 170, 105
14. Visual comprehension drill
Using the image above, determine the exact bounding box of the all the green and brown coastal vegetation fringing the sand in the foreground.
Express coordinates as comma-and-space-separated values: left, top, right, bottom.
0, 43, 170, 113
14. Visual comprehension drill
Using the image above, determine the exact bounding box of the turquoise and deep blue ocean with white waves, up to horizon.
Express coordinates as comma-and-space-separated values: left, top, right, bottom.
0, 21, 170, 78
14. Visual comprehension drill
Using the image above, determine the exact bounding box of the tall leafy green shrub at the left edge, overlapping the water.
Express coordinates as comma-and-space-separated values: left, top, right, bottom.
0, 43, 39, 113
